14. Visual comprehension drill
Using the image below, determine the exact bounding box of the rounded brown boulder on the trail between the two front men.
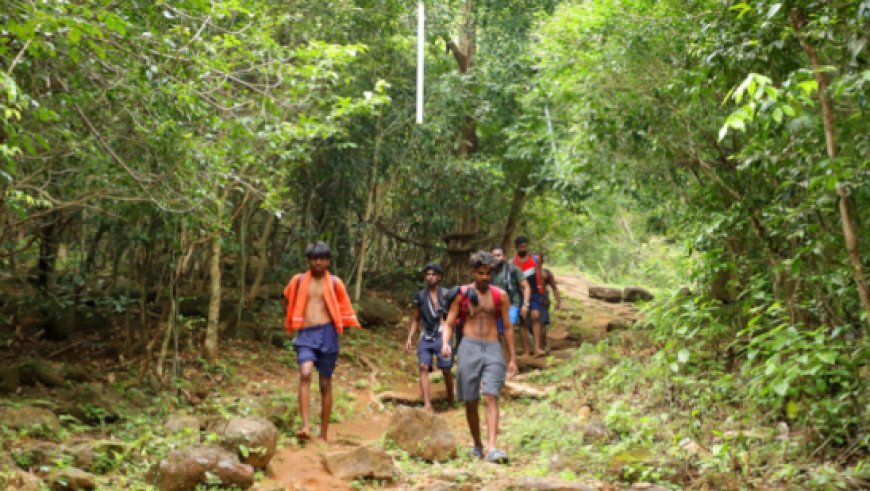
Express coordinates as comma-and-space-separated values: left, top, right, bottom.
386, 407, 456, 462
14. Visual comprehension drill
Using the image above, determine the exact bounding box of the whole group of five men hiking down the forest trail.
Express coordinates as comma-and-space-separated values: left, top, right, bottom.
284, 236, 561, 463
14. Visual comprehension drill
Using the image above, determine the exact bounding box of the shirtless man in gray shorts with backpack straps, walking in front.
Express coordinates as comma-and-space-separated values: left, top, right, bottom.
441, 251, 517, 463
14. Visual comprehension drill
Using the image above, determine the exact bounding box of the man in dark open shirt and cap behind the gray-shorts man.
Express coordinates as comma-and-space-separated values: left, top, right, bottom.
405, 263, 453, 412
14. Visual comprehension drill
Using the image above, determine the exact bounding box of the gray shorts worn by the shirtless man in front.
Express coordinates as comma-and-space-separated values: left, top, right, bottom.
456, 338, 507, 401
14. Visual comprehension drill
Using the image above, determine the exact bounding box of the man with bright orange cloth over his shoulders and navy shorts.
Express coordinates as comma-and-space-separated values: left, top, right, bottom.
284, 241, 360, 441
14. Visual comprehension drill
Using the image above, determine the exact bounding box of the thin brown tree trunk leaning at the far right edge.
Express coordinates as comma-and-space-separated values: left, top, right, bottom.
792, 11, 870, 326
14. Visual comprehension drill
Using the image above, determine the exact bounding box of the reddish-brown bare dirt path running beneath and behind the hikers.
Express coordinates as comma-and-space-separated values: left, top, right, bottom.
254, 274, 637, 491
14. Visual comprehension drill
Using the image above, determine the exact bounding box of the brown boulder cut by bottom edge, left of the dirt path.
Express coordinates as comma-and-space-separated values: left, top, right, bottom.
157, 446, 254, 491
